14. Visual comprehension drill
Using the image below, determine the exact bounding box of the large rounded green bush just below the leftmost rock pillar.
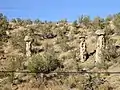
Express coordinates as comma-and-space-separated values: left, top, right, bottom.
28, 53, 60, 73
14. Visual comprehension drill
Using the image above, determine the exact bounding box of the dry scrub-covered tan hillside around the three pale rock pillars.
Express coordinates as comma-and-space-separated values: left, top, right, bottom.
0, 13, 120, 90
